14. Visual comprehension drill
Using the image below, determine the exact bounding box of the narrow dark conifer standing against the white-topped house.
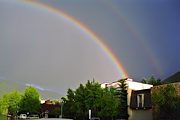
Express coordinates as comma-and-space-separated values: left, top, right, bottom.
117, 79, 129, 119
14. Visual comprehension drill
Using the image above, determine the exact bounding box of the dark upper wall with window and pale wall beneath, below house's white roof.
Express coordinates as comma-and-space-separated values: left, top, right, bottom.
129, 89, 152, 120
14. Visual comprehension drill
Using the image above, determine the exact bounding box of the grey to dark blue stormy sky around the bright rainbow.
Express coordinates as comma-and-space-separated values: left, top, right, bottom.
0, 0, 180, 94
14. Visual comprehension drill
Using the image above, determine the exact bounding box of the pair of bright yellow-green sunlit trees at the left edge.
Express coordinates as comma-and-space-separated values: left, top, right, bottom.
0, 86, 40, 119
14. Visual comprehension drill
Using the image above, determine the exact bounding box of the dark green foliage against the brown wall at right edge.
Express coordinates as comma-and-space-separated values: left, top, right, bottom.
152, 84, 180, 120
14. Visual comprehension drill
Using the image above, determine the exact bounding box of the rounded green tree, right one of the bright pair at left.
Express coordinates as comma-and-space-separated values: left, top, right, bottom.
20, 86, 40, 114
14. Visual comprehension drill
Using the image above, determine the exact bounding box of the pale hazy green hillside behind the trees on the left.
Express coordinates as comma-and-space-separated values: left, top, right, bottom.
0, 80, 61, 99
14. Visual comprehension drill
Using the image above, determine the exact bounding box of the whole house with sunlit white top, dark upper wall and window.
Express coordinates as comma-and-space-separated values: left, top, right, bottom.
101, 78, 153, 120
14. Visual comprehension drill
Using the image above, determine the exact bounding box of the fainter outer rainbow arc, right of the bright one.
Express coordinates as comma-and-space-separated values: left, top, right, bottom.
103, 1, 162, 76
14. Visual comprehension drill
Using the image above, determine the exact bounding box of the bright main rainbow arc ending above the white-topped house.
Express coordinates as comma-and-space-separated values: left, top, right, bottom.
22, 0, 128, 78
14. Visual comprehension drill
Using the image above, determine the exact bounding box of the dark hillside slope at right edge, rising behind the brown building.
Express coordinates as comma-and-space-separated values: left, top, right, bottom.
164, 71, 180, 83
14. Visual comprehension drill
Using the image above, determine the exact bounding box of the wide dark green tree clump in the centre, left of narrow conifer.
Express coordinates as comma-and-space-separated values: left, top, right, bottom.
62, 80, 119, 120
